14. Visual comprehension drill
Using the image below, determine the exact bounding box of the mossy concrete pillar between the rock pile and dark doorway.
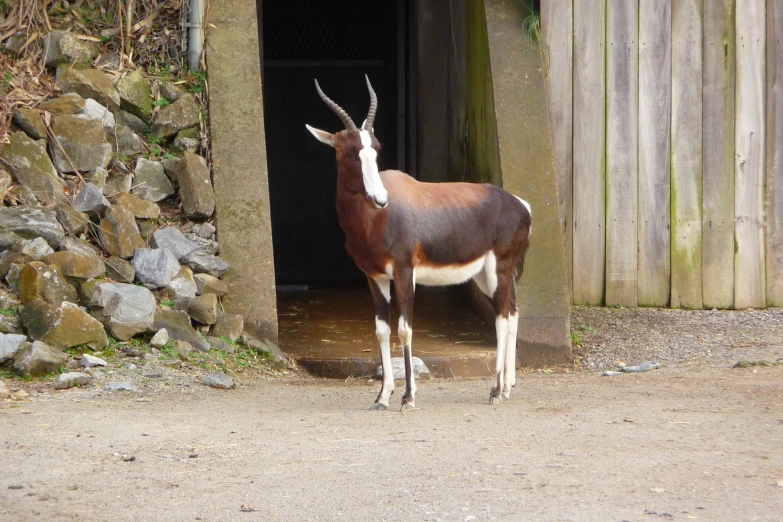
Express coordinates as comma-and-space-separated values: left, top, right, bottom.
205, 0, 277, 342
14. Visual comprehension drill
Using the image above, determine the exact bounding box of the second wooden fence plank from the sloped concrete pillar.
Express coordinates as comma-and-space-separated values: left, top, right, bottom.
573, 0, 606, 305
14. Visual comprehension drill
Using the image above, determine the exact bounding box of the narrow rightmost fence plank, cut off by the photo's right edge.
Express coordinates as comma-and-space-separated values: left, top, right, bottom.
766, 0, 783, 306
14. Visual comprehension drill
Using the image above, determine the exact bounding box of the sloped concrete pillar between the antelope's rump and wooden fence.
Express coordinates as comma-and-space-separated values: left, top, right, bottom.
476, 0, 573, 365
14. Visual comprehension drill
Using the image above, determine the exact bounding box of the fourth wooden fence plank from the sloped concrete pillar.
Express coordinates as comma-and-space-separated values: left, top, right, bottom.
637, 0, 672, 306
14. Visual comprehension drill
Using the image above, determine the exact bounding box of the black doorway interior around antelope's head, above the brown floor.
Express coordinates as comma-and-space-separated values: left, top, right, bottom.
258, 0, 408, 286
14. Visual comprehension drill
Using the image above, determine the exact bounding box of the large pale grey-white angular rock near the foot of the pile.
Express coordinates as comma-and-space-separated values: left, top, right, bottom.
90, 283, 156, 341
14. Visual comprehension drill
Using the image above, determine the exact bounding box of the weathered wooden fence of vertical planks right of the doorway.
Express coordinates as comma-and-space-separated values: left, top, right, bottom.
541, 0, 783, 308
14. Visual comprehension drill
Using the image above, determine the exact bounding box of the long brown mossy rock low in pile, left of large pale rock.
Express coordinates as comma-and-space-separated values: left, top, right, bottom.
19, 299, 109, 350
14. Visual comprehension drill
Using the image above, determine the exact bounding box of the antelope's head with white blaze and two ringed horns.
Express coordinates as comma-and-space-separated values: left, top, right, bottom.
305, 75, 389, 208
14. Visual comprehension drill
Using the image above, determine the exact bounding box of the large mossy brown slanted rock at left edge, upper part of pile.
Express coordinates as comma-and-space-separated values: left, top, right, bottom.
0, 131, 65, 203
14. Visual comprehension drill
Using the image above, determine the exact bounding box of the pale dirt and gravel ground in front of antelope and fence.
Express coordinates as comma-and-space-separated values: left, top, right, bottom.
0, 309, 783, 521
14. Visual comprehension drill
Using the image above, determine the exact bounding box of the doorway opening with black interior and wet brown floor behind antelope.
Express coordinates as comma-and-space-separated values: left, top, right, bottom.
257, 0, 494, 376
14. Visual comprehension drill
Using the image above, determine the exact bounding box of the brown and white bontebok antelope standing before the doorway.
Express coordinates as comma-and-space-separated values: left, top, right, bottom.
307, 77, 531, 411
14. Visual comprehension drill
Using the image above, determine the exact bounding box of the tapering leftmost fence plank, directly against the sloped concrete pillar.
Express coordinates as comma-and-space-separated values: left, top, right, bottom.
541, 0, 574, 295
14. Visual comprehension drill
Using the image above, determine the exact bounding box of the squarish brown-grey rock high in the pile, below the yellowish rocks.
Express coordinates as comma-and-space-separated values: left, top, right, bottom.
52, 115, 112, 172
